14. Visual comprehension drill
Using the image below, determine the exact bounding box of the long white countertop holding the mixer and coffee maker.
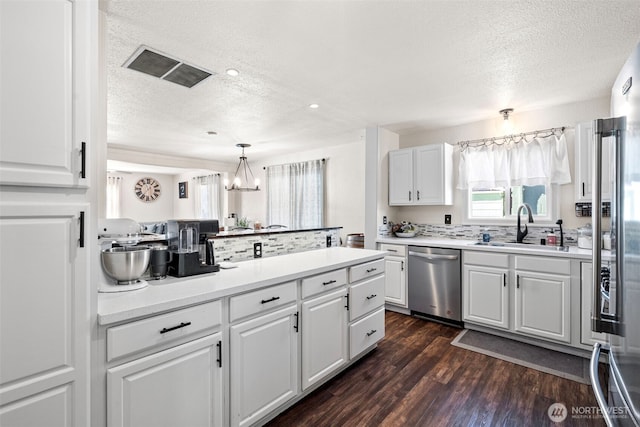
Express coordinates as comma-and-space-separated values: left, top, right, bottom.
98, 247, 385, 325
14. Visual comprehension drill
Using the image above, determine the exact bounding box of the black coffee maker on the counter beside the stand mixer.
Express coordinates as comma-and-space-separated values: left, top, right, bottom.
167, 220, 220, 277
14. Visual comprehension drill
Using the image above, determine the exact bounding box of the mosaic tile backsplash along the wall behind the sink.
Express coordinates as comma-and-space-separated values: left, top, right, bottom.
378, 224, 578, 246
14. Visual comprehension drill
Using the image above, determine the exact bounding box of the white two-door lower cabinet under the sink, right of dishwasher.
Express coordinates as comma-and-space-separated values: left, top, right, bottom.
463, 251, 571, 344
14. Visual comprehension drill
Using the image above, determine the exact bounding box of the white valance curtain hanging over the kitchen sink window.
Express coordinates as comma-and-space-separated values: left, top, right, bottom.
458, 133, 571, 189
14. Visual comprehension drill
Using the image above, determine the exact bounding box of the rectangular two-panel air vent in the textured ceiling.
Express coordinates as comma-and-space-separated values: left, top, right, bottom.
122, 46, 214, 88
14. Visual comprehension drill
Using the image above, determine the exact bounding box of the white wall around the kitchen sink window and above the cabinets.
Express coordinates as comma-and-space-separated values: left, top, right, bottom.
385, 97, 609, 228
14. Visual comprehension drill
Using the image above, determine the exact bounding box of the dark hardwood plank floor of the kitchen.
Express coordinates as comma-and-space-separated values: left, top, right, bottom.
268, 311, 605, 427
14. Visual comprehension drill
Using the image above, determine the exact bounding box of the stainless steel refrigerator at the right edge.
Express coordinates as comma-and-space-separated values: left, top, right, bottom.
591, 41, 640, 426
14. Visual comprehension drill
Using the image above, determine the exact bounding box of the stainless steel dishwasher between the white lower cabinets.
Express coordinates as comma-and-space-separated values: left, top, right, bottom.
408, 246, 462, 325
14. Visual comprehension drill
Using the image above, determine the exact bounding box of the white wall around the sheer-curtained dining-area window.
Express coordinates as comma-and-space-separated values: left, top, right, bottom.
235, 140, 365, 240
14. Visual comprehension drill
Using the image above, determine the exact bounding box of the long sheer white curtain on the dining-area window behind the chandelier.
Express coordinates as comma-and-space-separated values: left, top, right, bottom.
265, 160, 325, 229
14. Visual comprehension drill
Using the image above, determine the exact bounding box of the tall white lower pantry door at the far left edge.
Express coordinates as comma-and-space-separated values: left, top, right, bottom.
0, 202, 88, 425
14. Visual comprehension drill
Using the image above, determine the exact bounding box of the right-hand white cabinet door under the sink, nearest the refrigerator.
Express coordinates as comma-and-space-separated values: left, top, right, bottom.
515, 270, 571, 343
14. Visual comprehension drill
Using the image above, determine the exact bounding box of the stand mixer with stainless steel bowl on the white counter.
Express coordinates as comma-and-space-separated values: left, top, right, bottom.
98, 218, 151, 292
